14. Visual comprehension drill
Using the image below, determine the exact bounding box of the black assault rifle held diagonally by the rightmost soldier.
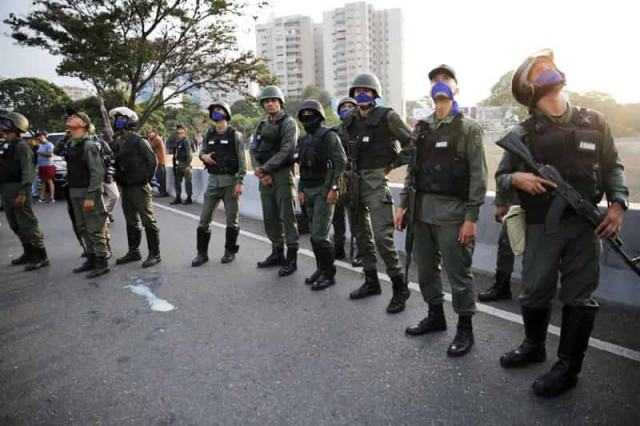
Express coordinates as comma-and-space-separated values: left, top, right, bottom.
496, 132, 640, 275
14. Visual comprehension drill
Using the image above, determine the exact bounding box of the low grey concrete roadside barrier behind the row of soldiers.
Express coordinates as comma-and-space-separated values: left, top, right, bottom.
167, 165, 640, 307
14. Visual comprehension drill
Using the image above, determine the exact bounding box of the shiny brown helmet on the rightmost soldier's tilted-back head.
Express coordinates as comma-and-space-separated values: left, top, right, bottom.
511, 49, 566, 107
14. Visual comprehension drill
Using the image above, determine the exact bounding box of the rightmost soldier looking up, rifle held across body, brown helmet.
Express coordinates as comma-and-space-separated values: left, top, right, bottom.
496, 50, 629, 396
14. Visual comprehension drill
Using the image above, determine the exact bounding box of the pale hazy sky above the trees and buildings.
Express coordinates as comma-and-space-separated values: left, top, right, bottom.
0, 0, 640, 105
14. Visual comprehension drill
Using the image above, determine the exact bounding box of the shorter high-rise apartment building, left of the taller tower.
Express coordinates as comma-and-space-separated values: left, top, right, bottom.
256, 15, 316, 96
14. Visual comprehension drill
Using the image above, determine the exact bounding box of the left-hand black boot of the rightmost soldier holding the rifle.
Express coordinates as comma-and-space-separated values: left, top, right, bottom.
500, 306, 551, 368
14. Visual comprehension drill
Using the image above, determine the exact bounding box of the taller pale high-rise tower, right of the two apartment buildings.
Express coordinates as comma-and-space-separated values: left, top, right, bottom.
323, 2, 405, 117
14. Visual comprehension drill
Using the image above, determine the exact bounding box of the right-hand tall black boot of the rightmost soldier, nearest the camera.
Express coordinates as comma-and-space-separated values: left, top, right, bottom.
531, 305, 598, 397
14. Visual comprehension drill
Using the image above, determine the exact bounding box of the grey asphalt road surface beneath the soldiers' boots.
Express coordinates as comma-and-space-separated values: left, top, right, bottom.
0, 202, 640, 425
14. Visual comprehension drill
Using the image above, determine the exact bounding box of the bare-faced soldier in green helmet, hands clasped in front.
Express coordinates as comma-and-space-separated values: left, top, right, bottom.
250, 86, 298, 277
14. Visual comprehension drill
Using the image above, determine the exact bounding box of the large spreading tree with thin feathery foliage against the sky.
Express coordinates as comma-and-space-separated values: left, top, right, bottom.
4, 0, 267, 140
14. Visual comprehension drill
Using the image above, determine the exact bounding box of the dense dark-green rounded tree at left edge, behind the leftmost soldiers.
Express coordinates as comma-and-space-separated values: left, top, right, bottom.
0, 78, 72, 130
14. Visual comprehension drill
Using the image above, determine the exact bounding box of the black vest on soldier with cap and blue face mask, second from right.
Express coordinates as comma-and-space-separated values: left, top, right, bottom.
415, 114, 470, 200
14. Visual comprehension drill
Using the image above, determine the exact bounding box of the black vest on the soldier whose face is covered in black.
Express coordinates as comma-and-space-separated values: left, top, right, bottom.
294, 126, 333, 188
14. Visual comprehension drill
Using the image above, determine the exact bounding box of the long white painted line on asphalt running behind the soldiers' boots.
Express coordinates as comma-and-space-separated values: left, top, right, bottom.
153, 203, 640, 362
